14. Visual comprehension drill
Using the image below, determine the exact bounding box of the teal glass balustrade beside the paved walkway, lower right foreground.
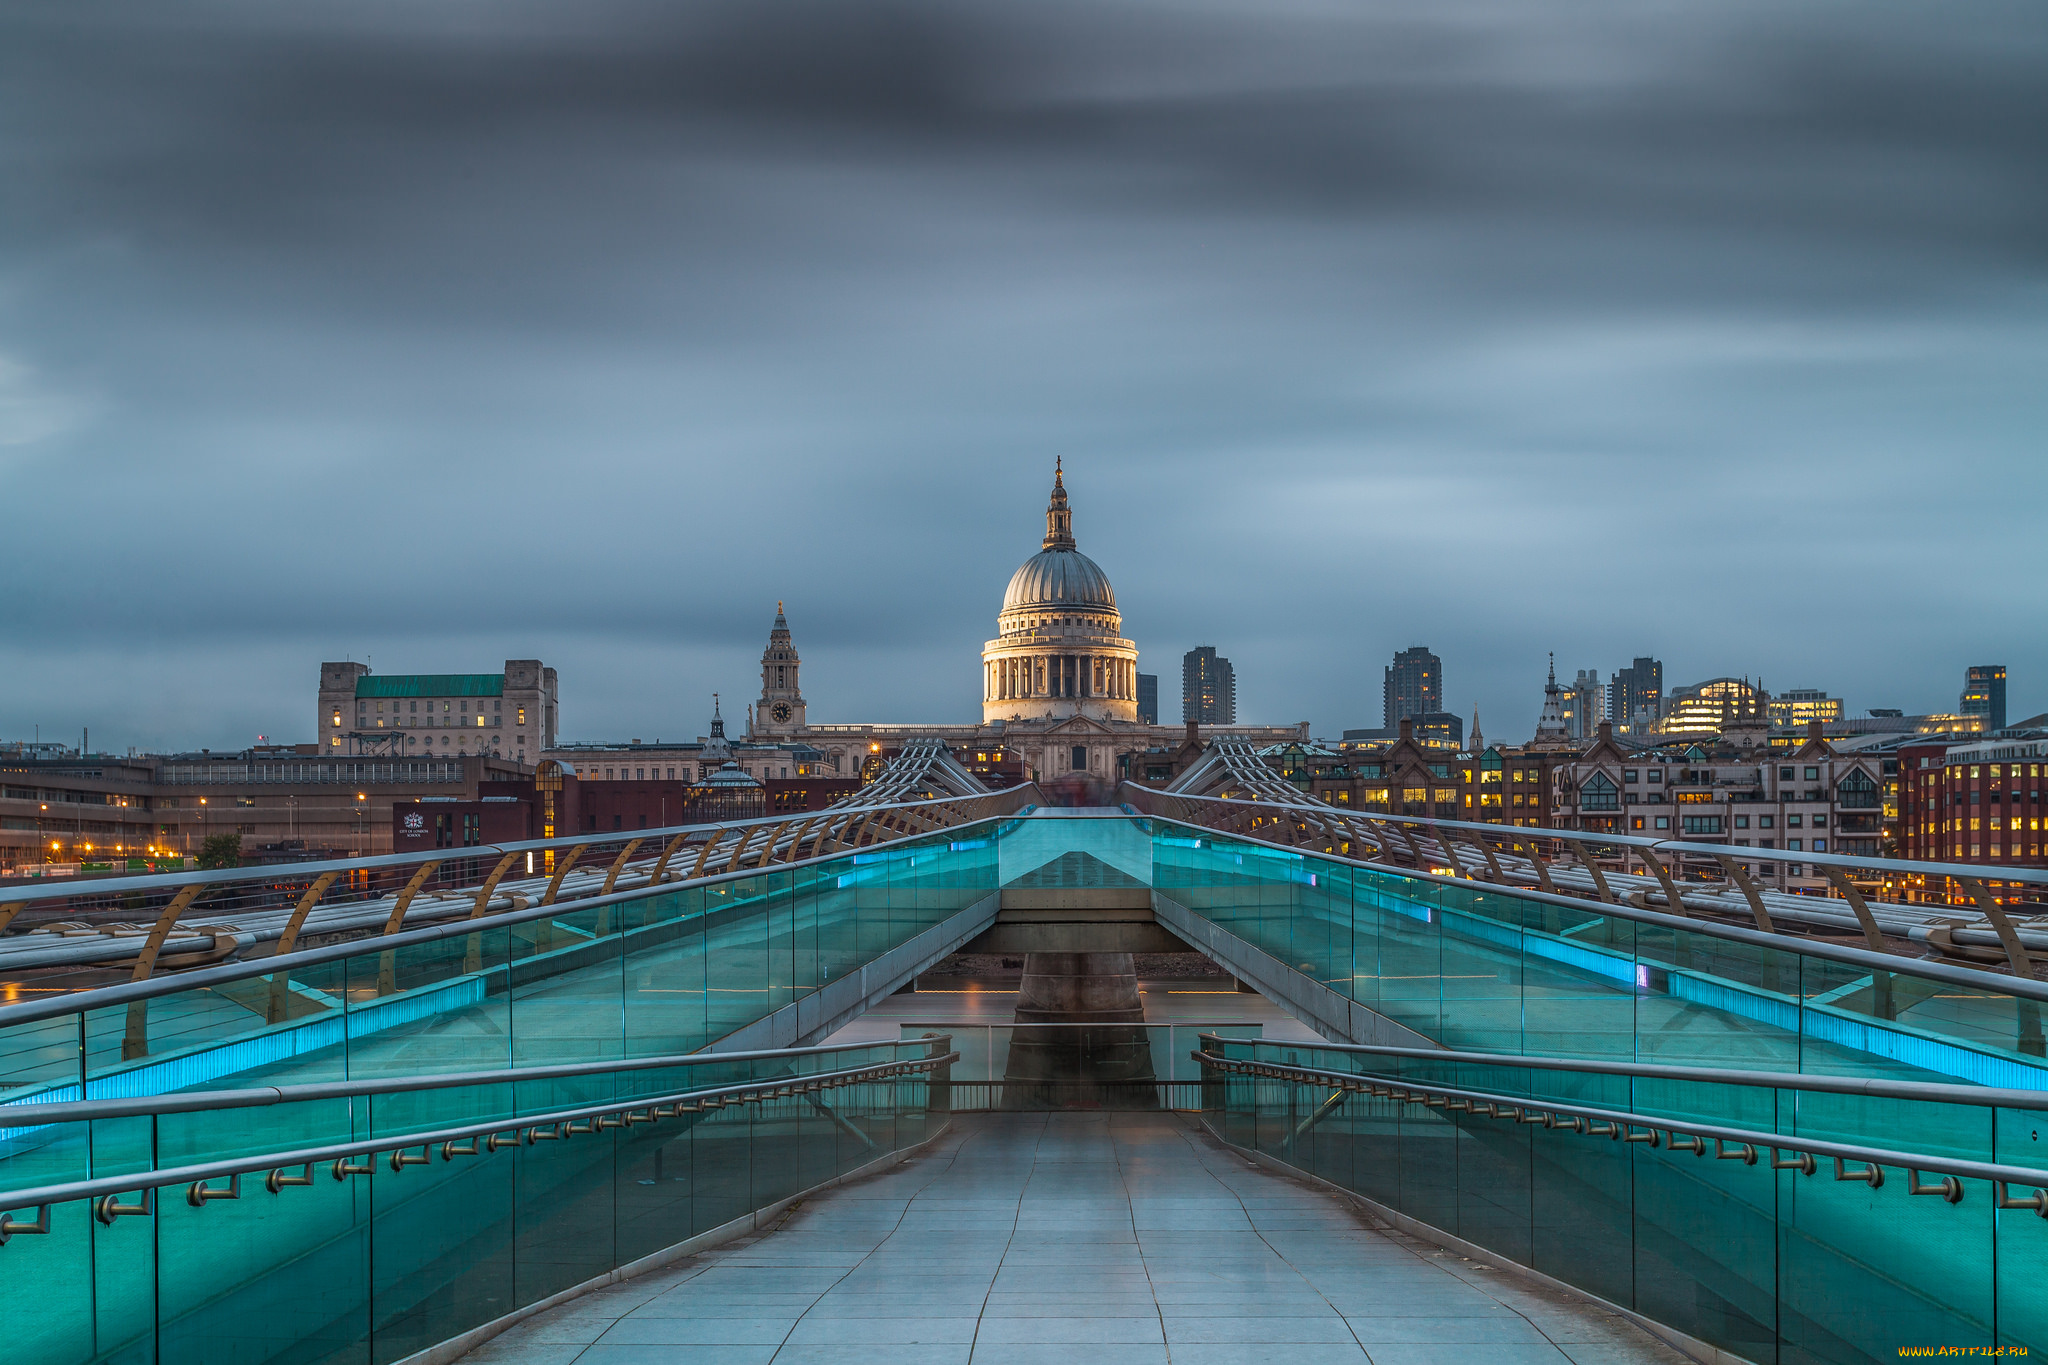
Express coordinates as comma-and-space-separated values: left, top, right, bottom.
1204, 1040, 2048, 1365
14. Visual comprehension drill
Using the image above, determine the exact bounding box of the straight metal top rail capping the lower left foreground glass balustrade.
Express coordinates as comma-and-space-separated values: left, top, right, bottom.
0, 1038, 924, 1128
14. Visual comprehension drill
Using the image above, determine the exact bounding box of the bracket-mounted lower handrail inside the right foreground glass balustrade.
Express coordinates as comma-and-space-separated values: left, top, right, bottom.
1190, 1052, 2048, 1218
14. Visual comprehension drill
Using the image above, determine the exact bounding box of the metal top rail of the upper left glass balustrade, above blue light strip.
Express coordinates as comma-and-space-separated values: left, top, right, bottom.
0, 806, 1016, 1029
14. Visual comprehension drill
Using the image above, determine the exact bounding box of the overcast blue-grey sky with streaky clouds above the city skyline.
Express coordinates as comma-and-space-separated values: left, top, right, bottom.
0, 0, 2048, 751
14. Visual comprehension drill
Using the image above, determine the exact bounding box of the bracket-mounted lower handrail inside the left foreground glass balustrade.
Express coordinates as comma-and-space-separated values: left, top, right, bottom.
0, 1052, 958, 1246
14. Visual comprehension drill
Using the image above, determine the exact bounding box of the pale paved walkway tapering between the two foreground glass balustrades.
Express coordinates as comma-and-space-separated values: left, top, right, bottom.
463, 1113, 1683, 1365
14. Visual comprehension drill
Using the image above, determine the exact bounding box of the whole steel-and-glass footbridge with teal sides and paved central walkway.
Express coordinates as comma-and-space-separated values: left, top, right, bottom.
0, 743, 2048, 1365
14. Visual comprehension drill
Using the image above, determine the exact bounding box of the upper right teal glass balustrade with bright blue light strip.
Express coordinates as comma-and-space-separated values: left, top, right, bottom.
1153, 821, 2048, 1089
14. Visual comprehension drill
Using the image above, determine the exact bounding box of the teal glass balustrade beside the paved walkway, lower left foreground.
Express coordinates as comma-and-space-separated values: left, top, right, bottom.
0, 1042, 936, 1365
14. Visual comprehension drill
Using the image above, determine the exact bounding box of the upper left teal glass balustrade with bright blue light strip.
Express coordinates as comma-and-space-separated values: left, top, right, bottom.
0, 827, 997, 1134
